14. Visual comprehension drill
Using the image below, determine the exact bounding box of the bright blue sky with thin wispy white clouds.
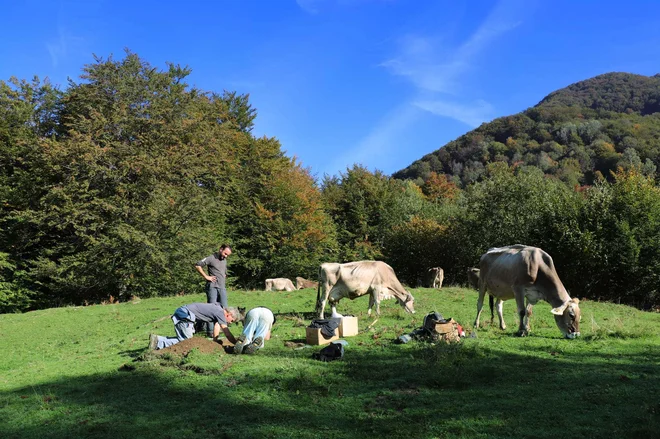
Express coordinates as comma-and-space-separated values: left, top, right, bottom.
0, 0, 660, 179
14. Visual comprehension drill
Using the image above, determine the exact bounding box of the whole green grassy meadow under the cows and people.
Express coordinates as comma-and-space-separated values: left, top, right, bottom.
0, 288, 660, 439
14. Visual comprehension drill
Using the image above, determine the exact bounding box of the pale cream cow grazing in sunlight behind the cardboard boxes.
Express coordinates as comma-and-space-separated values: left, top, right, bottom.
316, 261, 415, 318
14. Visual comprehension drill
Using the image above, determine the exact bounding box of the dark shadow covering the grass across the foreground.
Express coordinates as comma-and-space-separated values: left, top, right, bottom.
0, 342, 660, 439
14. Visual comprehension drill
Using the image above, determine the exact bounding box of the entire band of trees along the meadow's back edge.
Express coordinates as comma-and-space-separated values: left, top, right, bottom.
0, 52, 660, 312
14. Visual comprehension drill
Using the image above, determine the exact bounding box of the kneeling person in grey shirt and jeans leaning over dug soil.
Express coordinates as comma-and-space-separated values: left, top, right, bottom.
149, 302, 242, 349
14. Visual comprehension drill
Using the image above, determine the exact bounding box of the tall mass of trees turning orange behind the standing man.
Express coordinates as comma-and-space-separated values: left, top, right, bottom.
0, 52, 333, 309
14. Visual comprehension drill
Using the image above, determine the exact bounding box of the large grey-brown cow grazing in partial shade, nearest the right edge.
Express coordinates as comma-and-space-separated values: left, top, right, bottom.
474, 244, 581, 338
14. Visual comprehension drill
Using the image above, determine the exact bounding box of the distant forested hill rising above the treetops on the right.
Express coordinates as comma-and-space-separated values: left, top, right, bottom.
393, 73, 660, 187
